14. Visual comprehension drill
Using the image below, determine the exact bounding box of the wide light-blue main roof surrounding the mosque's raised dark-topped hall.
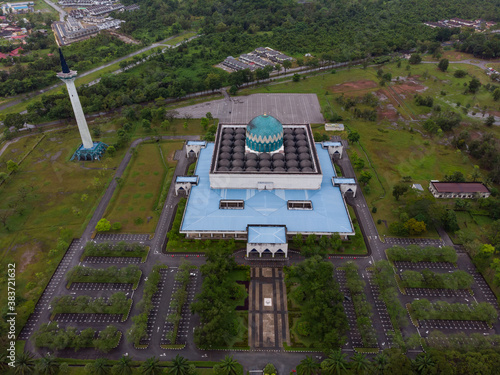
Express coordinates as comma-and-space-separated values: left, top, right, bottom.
181, 143, 354, 233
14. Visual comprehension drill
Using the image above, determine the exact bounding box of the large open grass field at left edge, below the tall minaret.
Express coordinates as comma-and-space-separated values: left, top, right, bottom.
0, 128, 127, 340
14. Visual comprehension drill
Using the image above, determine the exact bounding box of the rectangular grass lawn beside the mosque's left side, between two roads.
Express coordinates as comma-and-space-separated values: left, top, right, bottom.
105, 141, 183, 233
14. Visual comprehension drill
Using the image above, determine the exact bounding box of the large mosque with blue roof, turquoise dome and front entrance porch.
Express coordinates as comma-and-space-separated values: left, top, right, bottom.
175, 114, 356, 257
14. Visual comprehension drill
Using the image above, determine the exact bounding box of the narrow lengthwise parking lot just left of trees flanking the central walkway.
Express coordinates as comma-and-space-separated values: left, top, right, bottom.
161, 270, 201, 345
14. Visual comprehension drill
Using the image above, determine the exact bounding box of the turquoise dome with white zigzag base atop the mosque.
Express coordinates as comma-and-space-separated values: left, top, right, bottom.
246, 114, 283, 152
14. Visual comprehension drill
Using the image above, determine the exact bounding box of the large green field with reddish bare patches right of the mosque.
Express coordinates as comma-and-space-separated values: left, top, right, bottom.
240, 57, 499, 237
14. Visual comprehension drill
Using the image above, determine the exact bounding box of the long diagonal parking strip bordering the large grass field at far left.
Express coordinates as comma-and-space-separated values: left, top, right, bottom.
18, 240, 81, 340
